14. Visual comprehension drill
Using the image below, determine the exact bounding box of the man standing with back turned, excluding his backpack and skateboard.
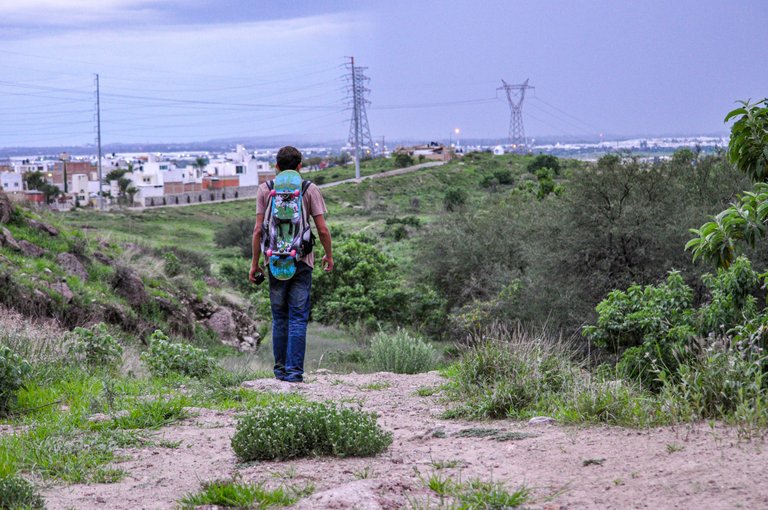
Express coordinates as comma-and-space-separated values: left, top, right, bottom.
248, 146, 333, 382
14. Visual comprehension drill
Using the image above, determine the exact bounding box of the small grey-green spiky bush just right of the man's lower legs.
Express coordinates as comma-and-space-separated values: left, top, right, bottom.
371, 329, 437, 374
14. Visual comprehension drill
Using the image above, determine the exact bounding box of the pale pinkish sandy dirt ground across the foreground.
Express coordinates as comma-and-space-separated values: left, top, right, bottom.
44, 373, 768, 510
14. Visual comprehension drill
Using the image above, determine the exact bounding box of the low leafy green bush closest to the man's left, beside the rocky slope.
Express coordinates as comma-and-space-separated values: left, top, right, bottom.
141, 330, 216, 378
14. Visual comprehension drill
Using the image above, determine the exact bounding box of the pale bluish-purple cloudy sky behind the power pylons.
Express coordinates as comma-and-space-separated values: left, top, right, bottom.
0, 0, 768, 147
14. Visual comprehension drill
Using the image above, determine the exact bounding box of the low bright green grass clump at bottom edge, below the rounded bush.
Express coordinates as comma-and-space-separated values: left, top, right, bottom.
179, 480, 315, 508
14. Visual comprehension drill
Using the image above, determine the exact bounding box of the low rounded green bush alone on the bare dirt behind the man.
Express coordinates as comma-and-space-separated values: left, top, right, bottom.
232, 402, 392, 462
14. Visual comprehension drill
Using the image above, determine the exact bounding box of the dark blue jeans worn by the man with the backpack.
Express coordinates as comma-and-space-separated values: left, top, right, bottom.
269, 262, 312, 382
